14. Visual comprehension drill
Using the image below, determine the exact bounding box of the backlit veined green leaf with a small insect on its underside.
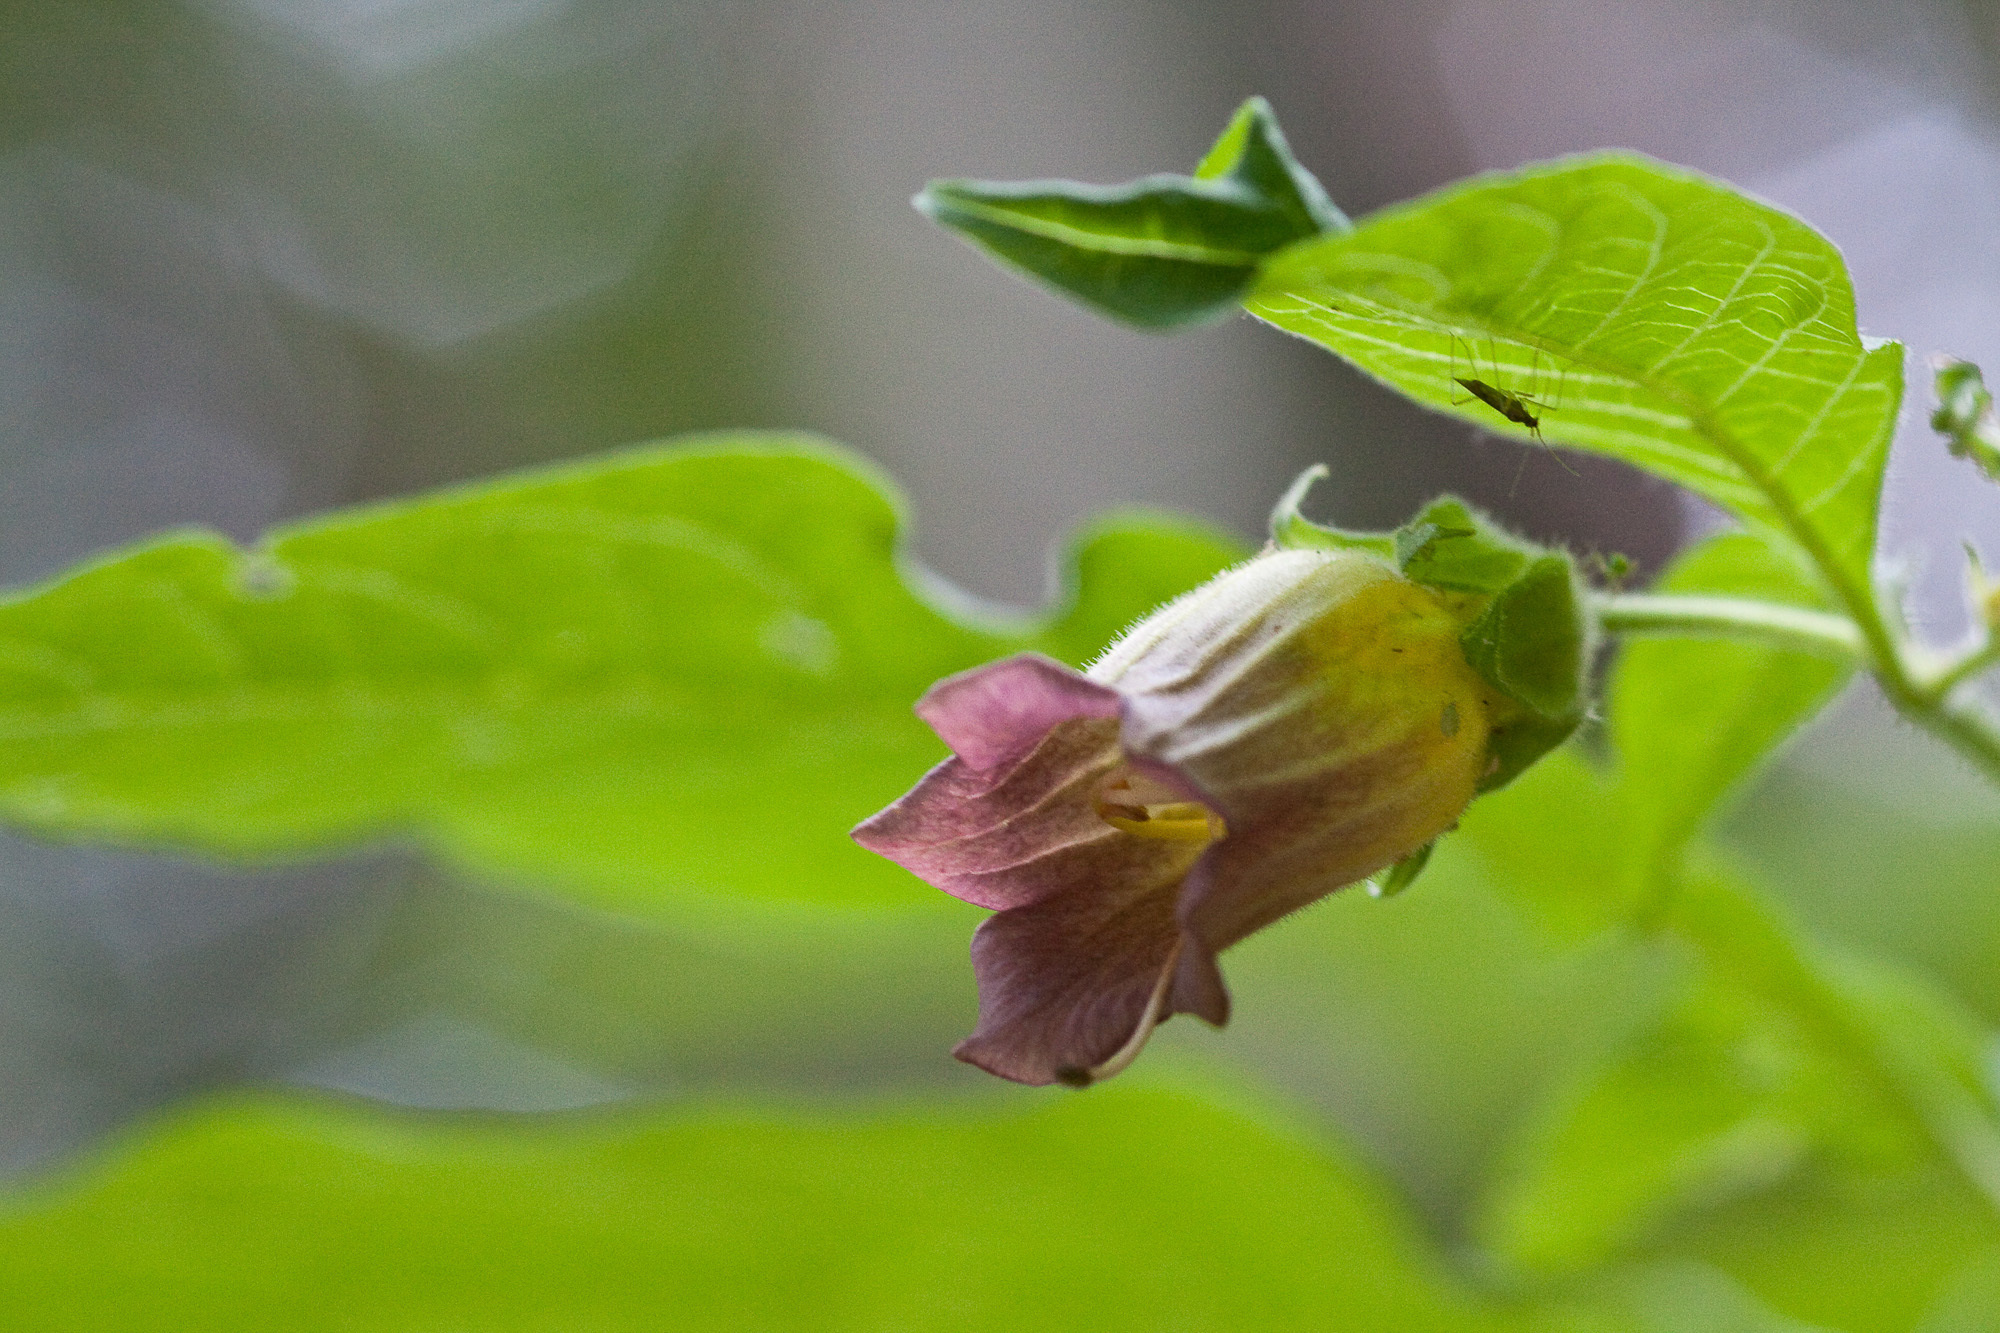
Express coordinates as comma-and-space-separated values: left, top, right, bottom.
1246, 154, 1902, 598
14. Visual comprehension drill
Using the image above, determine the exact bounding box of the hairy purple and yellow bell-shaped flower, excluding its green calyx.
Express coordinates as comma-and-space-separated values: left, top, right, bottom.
854, 550, 1512, 1085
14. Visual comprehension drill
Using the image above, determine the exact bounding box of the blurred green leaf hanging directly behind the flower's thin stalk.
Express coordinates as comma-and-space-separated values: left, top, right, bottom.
1610, 532, 1852, 892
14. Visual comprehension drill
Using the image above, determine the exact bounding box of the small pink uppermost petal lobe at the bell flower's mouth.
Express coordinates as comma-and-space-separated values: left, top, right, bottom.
916, 652, 1120, 769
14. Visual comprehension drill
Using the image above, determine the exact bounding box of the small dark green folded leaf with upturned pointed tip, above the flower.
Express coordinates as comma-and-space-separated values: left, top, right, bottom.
912, 98, 1346, 328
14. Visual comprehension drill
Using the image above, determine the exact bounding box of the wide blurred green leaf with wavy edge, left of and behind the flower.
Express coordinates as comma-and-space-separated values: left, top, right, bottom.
0, 436, 1238, 909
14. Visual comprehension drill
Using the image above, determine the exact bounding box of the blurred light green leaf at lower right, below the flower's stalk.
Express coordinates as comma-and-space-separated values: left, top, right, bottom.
1482, 869, 2000, 1296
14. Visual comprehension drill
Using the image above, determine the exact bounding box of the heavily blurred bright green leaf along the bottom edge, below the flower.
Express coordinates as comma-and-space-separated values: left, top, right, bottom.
0, 1087, 1494, 1333
